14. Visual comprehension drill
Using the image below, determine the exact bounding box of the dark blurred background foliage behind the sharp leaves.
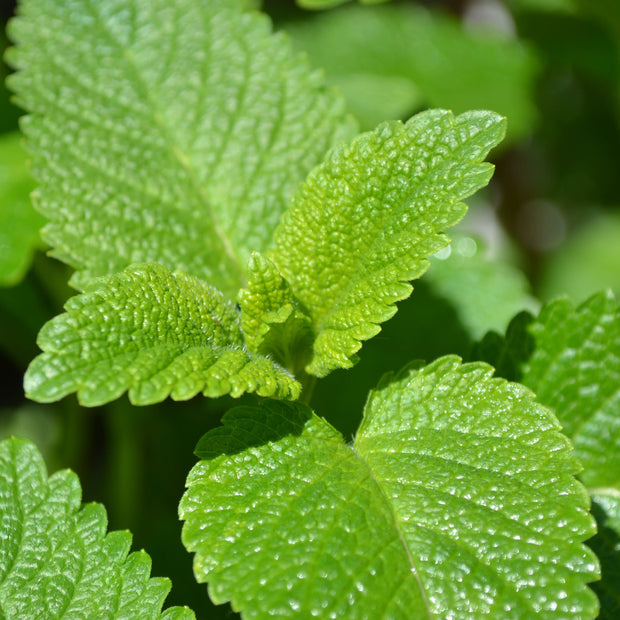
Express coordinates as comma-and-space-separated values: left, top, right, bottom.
0, 0, 620, 618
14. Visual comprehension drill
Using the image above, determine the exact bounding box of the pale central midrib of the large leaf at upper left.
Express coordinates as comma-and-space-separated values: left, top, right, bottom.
88, 3, 245, 286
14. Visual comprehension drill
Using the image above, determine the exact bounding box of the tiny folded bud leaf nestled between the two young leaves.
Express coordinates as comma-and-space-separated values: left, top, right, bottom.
239, 252, 312, 373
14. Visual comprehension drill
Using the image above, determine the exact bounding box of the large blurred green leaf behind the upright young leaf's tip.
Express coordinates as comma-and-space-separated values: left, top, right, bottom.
283, 2, 539, 139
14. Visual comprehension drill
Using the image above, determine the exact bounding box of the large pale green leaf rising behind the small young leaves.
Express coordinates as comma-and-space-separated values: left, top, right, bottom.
8, 0, 353, 299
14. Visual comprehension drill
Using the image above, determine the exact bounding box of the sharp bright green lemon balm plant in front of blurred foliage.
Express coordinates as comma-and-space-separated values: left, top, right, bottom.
0, 0, 620, 619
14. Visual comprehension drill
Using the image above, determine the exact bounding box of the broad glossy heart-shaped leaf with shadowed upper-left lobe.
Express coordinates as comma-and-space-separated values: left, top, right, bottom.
180, 357, 598, 620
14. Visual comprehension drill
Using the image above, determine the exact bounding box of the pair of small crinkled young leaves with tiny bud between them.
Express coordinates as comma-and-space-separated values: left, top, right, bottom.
25, 110, 505, 405
